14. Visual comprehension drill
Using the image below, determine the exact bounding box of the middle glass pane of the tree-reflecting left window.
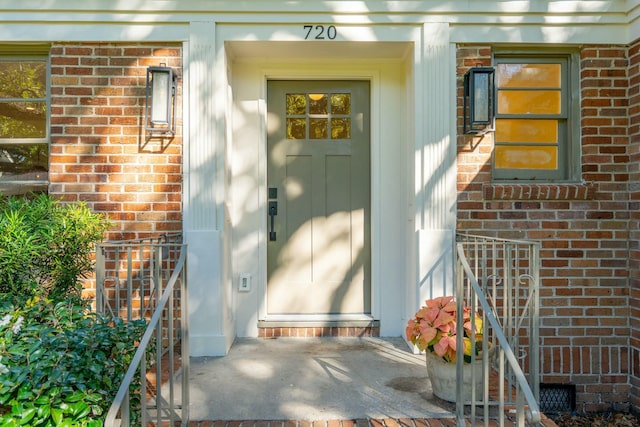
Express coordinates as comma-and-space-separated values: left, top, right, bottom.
0, 101, 47, 138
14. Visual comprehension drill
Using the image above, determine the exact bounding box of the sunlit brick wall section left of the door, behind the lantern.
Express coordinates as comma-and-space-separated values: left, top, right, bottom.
49, 43, 182, 244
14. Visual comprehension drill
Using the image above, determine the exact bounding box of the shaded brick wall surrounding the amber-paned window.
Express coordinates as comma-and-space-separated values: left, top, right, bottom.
457, 46, 638, 412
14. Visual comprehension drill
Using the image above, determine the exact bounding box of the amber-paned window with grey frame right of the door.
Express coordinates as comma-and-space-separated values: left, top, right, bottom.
493, 53, 580, 182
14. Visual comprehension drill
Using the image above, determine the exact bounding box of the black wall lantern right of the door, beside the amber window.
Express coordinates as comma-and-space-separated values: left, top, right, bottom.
464, 67, 495, 134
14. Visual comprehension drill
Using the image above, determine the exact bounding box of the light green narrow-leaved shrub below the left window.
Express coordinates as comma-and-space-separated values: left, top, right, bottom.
0, 195, 108, 301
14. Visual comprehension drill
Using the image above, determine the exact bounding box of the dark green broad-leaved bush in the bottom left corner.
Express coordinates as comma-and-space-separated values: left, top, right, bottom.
0, 297, 145, 427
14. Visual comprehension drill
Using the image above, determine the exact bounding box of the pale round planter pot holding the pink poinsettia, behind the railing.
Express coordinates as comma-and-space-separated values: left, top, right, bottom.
425, 352, 482, 403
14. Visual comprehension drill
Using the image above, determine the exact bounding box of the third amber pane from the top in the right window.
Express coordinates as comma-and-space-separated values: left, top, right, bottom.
495, 119, 558, 144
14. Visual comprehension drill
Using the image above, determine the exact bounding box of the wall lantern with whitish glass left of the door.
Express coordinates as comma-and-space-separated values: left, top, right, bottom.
144, 64, 177, 135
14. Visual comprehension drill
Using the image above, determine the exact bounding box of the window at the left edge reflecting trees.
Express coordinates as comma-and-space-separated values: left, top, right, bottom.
0, 47, 49, 195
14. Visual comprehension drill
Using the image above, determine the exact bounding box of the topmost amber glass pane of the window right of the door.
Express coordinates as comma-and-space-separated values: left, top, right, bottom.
496, 64, 562, 88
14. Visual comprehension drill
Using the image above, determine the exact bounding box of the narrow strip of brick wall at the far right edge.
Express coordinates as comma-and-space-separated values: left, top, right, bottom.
629, 41, 640, 409
